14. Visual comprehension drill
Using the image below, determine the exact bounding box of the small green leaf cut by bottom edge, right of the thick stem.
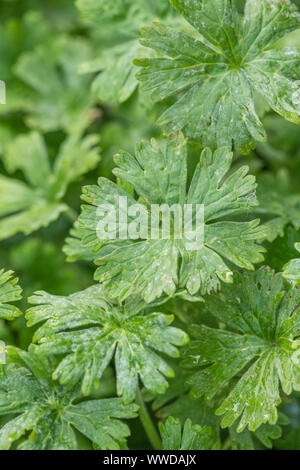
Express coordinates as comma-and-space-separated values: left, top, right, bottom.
159, 416, 220, 450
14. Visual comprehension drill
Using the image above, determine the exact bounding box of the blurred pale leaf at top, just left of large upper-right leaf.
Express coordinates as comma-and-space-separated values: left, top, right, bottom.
76, 0, 173, 103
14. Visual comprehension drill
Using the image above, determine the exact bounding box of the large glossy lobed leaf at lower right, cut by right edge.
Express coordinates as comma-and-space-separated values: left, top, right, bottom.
185, 268, 300, 432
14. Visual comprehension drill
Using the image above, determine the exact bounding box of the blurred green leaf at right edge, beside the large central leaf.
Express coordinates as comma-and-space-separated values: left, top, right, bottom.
257, 169, 300, 241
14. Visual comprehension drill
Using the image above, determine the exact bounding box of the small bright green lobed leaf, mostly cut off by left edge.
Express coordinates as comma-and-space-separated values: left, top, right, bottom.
0, 269, 22, 320
